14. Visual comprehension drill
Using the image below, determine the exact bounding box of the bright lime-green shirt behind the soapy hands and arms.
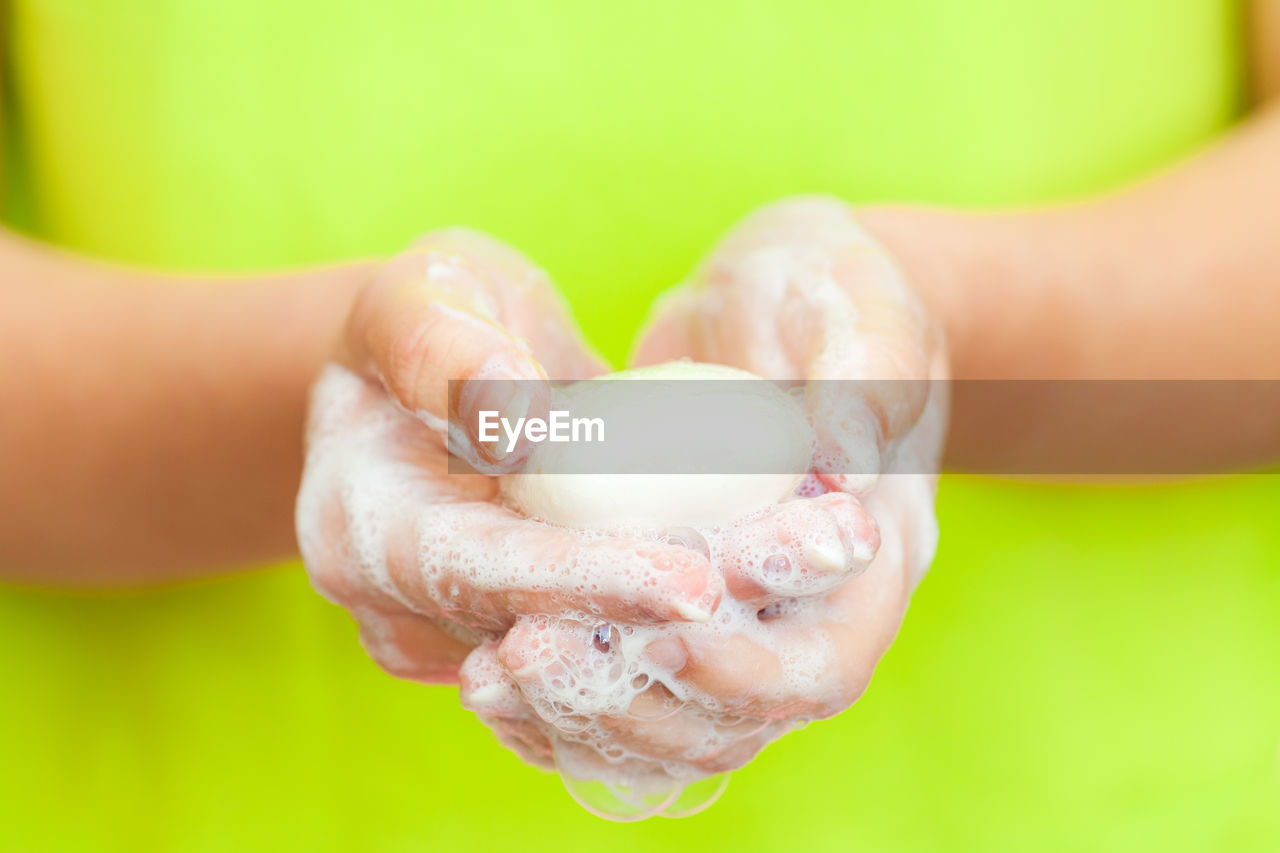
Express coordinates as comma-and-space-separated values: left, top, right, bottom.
0, 0, 1280, 852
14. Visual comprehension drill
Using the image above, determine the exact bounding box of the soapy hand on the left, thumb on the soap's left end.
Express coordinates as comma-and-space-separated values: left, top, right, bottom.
297, 229, 723, 681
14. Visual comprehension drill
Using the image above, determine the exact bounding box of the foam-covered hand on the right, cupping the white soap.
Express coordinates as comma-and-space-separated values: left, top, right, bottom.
462, 200, 946, 777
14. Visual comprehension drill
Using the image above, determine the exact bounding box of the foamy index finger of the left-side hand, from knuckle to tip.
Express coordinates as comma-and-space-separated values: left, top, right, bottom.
298, 384, 723, 625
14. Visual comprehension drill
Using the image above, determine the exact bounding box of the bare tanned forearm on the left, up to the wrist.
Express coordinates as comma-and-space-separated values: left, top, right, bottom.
0, 234, 369, 584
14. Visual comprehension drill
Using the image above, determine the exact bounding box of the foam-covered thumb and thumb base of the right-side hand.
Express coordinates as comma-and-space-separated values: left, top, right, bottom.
704, 197, 941, 493
